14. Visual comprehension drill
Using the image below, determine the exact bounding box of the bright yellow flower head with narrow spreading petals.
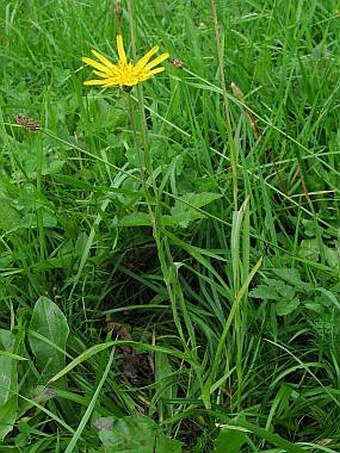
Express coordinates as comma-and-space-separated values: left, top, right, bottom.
82, 35, 169, 88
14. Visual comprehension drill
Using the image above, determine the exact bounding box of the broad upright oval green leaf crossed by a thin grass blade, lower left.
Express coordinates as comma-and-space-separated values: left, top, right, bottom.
29, 297, 69, 380
